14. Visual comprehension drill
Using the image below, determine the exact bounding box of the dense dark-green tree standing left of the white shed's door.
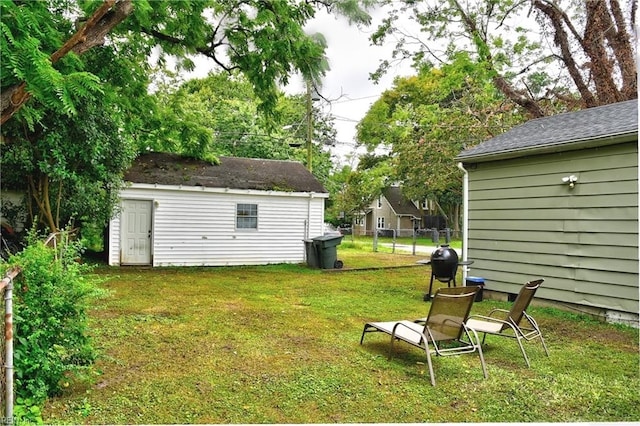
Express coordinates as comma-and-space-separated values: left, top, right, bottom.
0, 48, 141, 232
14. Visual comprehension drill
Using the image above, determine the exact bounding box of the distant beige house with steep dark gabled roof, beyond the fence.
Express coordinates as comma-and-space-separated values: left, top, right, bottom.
356, 186, 421, 237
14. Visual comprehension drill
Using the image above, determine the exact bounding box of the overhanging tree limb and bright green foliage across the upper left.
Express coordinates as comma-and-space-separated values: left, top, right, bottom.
0, 0, 369, 123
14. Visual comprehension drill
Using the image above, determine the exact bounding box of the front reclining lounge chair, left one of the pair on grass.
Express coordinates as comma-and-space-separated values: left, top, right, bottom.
360, 287, 487, 386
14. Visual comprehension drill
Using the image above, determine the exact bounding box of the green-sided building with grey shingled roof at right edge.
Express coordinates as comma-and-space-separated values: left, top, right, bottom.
457, 100, 639, 324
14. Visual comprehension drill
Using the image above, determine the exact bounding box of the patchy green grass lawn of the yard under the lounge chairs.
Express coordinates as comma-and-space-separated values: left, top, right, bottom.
44, 250, 640, 424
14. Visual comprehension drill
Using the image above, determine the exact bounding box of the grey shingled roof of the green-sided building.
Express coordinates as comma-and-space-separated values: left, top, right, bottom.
456, 99, 638, 161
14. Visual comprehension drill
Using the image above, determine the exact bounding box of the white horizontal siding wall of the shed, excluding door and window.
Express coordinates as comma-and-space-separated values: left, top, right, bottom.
109, 185, 327, 266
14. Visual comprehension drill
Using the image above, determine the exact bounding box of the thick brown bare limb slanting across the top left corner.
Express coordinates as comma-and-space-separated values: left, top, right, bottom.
0, 0, 133, 124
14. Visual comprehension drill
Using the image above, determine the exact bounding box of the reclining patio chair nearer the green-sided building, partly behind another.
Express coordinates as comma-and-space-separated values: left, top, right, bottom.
467, 279, 549, 367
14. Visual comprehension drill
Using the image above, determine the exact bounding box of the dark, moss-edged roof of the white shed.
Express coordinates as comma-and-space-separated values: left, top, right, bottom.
124, 152, 327, 193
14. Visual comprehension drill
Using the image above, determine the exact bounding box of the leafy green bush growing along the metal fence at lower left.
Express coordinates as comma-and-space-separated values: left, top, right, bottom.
1, 236, 97, 422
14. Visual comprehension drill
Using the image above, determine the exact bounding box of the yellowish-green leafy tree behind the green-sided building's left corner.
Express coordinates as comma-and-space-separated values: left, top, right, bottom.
357, 54, 523, 229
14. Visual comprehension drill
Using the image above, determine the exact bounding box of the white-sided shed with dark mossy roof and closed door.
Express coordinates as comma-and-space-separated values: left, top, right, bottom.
108, 153, 329, 266
